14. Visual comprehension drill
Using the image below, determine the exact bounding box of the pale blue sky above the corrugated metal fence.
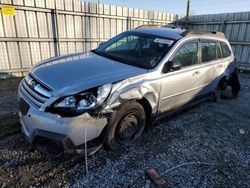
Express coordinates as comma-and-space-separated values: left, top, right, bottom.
85, 0, 250, 15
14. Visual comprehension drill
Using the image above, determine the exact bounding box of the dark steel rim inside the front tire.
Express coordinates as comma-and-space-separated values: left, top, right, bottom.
117, 113, 139, 142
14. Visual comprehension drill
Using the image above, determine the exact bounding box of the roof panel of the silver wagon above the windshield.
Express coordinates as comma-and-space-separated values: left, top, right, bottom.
131, 27, 186, 40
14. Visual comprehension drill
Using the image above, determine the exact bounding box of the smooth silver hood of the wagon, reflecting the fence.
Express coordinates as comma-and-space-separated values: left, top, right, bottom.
31, 52, 147, 96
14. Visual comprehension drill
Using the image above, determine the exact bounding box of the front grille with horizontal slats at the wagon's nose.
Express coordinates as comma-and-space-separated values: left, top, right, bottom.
20, 75, 52, 108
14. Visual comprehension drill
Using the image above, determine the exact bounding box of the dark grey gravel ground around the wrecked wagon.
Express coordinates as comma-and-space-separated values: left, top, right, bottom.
0, 75, 250, 187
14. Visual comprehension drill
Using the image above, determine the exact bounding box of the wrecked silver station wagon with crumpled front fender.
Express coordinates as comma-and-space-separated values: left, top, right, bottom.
18, 28, 240, 156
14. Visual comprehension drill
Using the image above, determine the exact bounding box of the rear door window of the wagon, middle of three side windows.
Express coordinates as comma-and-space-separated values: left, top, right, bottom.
201, 42, 218, 62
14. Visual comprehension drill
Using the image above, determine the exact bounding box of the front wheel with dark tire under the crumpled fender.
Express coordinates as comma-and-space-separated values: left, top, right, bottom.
105, 101, 146, 150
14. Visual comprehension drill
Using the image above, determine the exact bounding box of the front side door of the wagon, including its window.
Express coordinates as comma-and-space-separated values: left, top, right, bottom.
158, 40, 201, 114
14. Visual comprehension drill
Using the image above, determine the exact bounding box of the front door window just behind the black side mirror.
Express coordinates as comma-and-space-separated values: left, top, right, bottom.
173, 42, 198, 67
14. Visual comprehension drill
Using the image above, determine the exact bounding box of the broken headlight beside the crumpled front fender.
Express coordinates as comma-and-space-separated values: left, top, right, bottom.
48, 84, 112, 116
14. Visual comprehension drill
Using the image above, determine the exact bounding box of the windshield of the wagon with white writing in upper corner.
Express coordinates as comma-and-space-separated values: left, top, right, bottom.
92, 32, 174, 69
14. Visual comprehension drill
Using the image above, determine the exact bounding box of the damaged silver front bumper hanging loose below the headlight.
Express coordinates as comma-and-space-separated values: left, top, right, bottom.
18, 94, 108, 155
